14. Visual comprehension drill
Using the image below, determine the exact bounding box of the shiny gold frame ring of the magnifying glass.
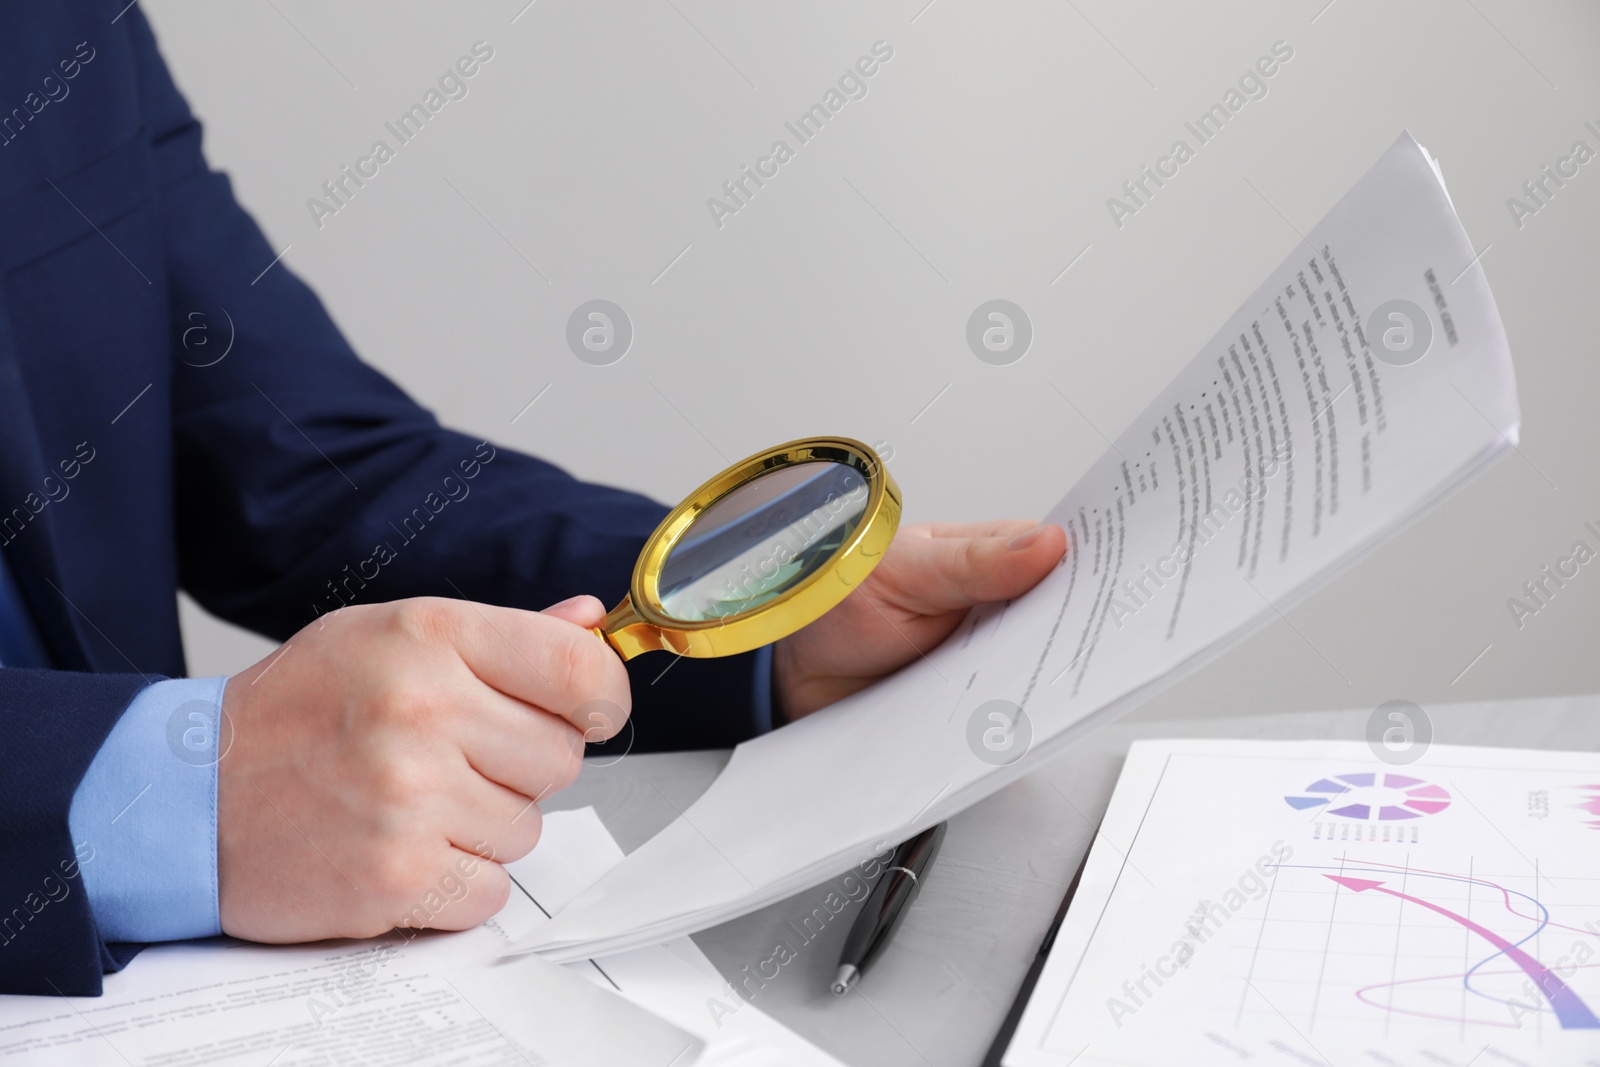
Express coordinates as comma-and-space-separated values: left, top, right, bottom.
594, 437, 901, 659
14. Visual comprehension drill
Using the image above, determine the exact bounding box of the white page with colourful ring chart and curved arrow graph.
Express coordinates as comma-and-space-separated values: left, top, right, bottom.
1003, 741, 1600, 1067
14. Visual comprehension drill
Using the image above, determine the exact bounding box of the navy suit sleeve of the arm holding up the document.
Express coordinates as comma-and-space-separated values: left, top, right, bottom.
128, 8, 754, 752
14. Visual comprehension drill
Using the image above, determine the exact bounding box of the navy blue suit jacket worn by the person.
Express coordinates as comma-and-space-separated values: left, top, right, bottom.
0, 0, 752, 995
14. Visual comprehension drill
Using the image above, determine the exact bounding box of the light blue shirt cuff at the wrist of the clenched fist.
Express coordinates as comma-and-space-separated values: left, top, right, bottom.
67, 678, 227, 942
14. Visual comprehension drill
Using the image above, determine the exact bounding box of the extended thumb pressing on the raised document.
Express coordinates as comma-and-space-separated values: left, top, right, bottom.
883, 525, 1067, 614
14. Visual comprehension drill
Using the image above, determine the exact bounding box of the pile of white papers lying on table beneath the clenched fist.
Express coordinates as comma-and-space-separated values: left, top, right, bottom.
0, 808, 837, 1067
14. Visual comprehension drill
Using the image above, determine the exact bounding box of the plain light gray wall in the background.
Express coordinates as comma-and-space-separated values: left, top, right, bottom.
144, 0, 1600, 717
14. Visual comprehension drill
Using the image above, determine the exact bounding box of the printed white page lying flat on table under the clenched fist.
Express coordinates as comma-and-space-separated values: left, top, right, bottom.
0, 883, 701, 1067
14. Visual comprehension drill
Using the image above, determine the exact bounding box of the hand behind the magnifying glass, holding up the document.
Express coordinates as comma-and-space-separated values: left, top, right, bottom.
773, 520, 1067, 720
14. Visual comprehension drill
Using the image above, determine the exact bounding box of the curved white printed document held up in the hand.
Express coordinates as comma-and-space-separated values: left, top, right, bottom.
505, 134, 1518, 960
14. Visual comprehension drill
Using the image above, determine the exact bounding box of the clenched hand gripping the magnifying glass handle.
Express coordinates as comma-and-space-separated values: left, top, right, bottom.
216, 597, 630, 942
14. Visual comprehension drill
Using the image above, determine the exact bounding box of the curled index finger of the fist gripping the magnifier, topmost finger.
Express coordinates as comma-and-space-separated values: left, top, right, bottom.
425, 600, 634, 739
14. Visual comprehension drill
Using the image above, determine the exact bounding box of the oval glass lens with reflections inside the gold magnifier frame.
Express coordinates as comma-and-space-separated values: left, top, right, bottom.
659, 461, 867, 622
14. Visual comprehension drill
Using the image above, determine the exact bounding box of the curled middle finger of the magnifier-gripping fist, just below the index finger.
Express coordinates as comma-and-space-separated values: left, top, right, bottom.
454, 689, 595, 800
